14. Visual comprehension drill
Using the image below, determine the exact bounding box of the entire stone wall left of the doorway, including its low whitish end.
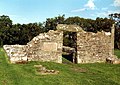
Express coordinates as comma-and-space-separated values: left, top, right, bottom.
3, 30, 63, 63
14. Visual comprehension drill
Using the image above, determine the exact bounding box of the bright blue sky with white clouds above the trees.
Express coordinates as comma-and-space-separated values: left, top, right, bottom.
0, 0, 120, 24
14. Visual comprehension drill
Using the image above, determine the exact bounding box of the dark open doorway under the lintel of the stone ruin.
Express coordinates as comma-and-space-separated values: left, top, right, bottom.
62, 31, 77, 63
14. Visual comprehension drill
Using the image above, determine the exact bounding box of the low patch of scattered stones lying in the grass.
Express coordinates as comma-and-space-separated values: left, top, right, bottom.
34, 65, 59, 75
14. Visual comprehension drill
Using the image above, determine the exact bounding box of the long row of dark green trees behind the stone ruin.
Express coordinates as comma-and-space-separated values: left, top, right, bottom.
0, 14, 120, 49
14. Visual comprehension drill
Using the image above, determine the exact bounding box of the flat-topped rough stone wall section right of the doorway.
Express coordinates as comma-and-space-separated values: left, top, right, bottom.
77, 32, 112, 63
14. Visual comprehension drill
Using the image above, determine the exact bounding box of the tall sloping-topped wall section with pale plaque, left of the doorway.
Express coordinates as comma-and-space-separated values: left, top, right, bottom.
27, 30, 63, 63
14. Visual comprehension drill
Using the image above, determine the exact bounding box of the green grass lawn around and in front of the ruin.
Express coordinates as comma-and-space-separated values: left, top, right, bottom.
0, 48, 120, 85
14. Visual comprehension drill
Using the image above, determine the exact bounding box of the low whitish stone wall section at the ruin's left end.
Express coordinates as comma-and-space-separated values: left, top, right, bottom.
3, 45, 27, 63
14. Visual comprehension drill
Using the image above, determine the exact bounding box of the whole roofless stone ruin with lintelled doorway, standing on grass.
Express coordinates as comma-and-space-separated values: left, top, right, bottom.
3, 24, 115, 63
